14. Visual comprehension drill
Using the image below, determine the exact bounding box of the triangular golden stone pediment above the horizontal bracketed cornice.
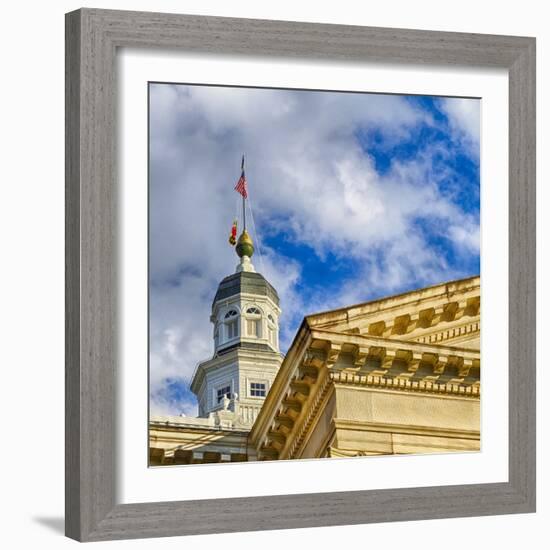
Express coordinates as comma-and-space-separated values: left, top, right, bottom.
306, 277, 480, 350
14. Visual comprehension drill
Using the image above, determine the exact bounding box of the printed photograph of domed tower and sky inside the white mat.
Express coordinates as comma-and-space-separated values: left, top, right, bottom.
148, 82, 481, 467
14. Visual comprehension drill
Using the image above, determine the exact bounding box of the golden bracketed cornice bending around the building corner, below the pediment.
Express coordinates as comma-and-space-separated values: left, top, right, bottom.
250, 323, 480, 460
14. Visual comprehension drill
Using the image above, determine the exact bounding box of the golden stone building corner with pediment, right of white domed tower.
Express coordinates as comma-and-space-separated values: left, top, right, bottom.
249, 277, 480, 460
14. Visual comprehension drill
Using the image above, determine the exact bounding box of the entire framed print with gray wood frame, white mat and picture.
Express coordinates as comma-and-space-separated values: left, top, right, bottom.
66, 9, 535, 540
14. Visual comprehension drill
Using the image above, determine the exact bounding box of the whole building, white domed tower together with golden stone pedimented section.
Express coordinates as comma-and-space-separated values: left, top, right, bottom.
149, 235, 480, 465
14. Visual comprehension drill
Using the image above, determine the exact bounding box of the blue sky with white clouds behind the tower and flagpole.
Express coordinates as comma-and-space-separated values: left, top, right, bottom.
149, 84, 480, 414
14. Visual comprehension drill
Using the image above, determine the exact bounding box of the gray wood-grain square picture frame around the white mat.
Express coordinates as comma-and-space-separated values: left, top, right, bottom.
66, 9, 536, 541
